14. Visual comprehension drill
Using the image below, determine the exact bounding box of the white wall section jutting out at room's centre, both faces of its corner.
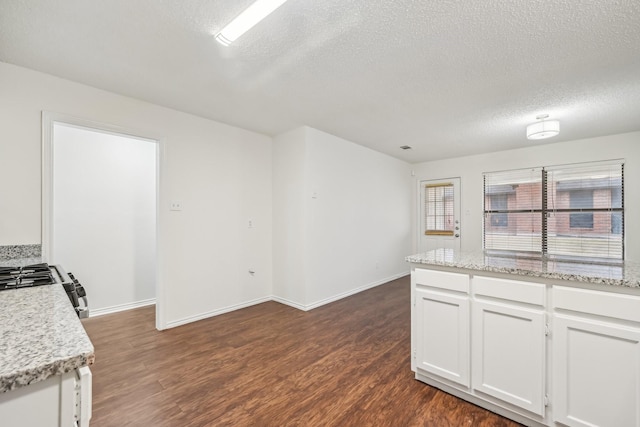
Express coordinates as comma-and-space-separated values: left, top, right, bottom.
274, 127, 411, 309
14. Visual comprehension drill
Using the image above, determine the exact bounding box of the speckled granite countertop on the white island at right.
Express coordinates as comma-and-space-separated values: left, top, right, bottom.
405, 249, 640, 288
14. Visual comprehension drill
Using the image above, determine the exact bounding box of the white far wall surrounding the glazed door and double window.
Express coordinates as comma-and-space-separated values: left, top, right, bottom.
412, 132, 640, 260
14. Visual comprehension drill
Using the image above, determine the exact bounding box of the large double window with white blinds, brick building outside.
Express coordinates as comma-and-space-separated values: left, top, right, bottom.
483, 161, 624, 260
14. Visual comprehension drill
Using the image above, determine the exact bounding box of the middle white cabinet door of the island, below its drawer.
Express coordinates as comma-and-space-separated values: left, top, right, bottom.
471, 301, 546, 416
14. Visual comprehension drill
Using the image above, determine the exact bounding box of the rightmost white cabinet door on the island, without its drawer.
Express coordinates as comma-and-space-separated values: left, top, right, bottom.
552, 314, 640, 427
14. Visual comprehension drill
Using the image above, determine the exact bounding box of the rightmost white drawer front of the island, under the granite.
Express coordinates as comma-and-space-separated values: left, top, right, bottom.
551, 286, 640, 323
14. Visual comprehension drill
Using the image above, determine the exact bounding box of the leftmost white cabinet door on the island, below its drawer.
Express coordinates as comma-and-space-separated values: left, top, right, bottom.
416, 289, 470, 387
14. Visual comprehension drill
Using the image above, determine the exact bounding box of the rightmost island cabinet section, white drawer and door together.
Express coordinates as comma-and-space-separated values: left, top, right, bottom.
553, 287, 640, 427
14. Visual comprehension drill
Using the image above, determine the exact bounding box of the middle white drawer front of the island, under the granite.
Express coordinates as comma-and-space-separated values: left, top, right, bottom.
473, 276, 546, 306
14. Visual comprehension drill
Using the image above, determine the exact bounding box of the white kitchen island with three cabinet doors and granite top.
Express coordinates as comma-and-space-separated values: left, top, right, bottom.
406, 249, 640, 426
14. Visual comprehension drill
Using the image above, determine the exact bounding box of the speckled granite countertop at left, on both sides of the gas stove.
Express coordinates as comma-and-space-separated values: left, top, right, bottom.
0, 257, 95, 393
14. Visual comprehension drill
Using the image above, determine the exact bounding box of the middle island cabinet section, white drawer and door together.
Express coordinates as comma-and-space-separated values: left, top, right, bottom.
471, 277, 546, 417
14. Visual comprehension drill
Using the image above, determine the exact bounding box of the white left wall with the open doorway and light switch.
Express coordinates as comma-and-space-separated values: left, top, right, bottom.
0, 63, 272, 326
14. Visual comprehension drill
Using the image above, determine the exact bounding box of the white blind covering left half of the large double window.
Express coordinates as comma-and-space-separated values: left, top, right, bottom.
484, 168, 542, 252
